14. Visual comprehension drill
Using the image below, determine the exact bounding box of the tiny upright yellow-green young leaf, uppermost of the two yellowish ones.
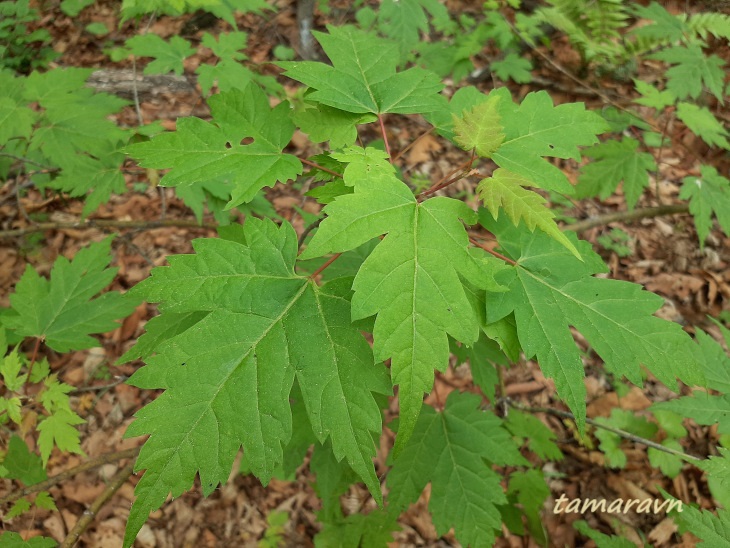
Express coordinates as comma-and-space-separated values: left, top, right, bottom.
454, 95, 504, 158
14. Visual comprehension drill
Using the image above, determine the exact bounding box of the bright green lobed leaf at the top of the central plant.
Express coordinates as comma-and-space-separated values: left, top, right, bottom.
276, 26, 443, 114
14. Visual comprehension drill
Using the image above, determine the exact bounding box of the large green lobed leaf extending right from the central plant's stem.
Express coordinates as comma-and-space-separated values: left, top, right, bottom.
480, 215, 705, 429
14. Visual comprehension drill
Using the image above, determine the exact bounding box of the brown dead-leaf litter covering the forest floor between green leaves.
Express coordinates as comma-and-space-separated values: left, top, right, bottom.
0, 0, 730, 548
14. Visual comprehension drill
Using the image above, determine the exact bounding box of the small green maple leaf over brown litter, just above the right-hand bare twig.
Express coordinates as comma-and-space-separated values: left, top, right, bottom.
576, 138, 656, 209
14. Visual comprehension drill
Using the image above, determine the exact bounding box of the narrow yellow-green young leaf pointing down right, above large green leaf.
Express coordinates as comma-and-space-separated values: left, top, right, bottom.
477, 168, 580, 259
